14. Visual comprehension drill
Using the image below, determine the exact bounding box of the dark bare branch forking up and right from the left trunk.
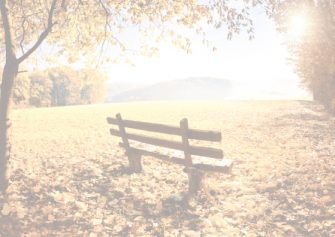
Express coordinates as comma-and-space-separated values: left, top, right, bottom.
18, 0, 57, 63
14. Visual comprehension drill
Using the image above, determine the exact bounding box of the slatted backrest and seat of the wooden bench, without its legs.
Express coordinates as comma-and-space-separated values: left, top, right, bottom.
107, 114, 231, 172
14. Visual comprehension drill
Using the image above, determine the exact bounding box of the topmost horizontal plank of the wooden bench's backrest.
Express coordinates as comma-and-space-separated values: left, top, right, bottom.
107, 117, 222, 142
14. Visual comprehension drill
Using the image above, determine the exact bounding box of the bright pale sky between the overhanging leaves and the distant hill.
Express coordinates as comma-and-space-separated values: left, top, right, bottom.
108, 10, 308, 98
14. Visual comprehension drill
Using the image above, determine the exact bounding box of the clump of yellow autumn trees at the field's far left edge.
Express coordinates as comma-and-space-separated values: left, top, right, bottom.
9, 67, 107, 107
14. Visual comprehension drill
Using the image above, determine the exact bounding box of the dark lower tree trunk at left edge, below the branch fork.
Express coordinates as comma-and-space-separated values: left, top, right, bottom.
0, 57, 19, 193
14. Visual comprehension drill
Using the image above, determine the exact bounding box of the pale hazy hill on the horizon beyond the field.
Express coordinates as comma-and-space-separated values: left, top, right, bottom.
109, 77, 232, 102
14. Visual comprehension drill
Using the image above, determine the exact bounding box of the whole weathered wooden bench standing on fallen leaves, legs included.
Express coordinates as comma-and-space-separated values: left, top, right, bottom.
107, 114, 233, 195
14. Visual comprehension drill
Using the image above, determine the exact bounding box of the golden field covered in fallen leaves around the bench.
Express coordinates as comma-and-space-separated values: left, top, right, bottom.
0, 101, 335, 237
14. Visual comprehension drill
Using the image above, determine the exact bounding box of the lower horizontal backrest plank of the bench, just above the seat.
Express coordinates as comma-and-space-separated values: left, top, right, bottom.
110, 129, 223, 159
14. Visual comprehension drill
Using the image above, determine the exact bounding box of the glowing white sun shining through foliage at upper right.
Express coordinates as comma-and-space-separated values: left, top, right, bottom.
288, 14, 309, 39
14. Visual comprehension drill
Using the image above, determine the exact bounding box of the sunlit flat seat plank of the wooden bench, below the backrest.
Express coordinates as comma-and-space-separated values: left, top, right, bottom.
120, 143, 233, 174
